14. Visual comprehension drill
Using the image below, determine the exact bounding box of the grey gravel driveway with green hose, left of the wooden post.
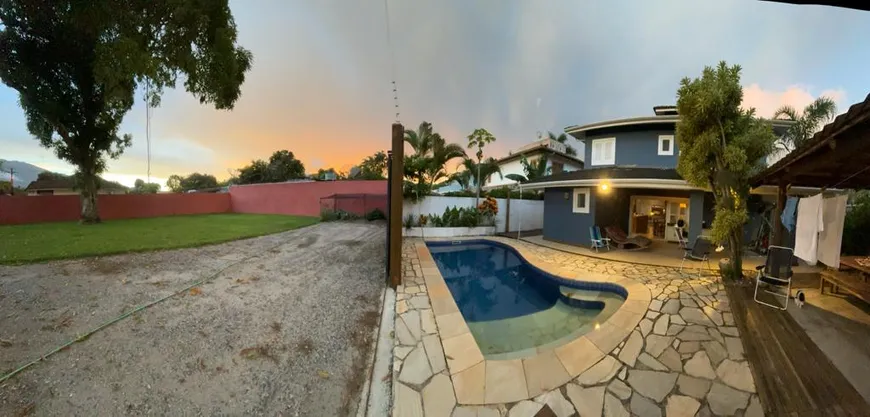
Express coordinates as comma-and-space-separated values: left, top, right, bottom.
0, 222, 386, 416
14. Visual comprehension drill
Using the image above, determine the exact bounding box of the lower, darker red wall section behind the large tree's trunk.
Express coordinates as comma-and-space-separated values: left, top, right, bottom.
0, 194, 232, 224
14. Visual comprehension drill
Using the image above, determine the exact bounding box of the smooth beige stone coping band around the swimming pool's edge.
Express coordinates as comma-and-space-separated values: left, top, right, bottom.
414, 236, 652, 405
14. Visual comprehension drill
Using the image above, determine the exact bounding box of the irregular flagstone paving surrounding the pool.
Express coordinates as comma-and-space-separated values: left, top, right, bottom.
393, 238, 763, 417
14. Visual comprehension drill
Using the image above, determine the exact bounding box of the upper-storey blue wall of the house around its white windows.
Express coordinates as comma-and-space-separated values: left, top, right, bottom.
584, 129, 680, 168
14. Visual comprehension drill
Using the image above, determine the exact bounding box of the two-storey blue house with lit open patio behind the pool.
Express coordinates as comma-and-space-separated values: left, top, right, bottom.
523, 106, 790, 246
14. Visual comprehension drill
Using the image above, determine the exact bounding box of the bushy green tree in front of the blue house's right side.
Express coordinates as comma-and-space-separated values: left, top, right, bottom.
676, 61, 776, 278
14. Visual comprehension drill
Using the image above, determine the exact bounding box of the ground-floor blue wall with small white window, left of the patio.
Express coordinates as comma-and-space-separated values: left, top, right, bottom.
543, 187, 596, 246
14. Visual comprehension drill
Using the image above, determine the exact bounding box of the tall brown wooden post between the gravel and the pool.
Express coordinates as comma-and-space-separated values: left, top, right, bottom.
389, 123, 405, 288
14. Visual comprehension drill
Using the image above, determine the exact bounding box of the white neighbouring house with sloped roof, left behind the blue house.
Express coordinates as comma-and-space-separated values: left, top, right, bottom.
483, 139, 588, 189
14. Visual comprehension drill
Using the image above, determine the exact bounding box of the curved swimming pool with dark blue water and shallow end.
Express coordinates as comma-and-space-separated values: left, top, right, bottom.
426, 240, 627, 359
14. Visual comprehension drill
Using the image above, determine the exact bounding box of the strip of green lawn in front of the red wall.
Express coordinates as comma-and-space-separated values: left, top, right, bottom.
0, 214, 319, 264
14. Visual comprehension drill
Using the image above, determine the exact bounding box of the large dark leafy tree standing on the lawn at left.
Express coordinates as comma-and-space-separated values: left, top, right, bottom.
0, 0, 252, 223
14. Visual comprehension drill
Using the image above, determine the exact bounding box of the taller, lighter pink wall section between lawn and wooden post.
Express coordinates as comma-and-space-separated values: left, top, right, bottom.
230, 181, 387, 216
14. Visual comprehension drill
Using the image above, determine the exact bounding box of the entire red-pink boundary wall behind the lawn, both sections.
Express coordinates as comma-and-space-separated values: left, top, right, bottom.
0, 181, 387, 225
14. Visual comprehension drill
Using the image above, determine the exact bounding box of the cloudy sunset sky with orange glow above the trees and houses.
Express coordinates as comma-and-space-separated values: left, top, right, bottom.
0, 0, 870, 185
